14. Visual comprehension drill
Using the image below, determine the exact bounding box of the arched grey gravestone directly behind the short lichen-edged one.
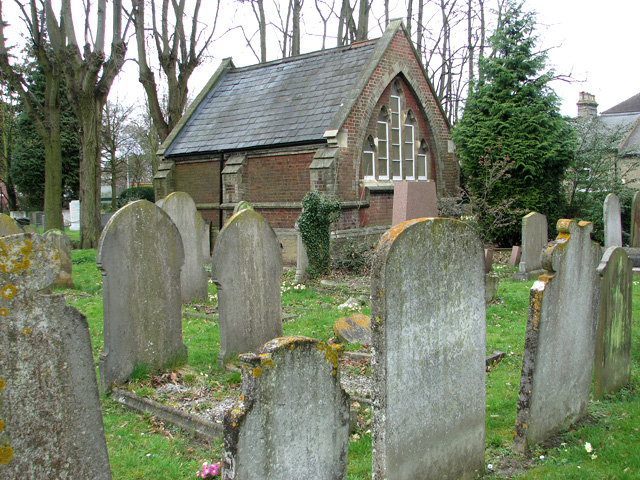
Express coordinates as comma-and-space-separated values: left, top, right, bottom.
213, 208, 282, 365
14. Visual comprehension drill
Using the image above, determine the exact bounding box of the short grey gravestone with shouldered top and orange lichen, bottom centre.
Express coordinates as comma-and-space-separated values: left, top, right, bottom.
222, 337, 349, 480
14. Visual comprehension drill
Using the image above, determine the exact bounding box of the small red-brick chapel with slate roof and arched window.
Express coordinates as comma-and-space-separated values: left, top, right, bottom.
154, 20, 459, 261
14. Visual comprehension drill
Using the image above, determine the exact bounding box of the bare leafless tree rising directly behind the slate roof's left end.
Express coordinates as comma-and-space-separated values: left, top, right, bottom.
131, 0, 220, 142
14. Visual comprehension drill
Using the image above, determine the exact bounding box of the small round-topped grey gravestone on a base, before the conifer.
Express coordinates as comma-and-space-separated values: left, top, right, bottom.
513, 212, 549, 281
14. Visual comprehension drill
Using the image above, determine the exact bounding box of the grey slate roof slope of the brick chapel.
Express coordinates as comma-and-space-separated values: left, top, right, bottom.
164, 41, 376, 157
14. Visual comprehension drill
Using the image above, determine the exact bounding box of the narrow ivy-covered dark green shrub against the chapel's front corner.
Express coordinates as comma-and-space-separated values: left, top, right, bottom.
297, 191, 341, 277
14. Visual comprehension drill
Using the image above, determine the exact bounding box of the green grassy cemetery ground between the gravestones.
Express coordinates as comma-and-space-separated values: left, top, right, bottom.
57, 244, 640, 480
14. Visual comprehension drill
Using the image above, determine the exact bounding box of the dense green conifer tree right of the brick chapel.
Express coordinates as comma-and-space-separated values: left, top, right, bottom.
453, 1, 575, 244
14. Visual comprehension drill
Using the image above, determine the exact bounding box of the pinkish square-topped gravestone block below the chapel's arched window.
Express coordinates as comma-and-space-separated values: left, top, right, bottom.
391, 181, 438, 225
